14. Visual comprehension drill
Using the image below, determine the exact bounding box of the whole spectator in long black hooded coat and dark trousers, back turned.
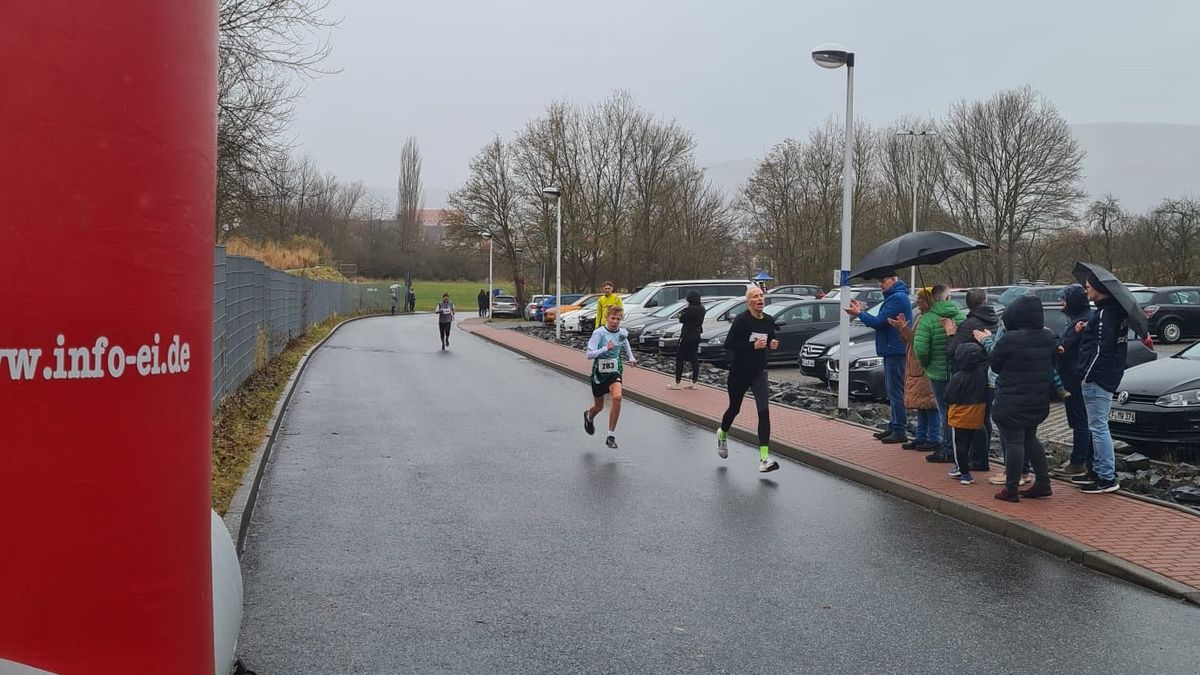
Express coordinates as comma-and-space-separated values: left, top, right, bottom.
991, 295, 1057, 502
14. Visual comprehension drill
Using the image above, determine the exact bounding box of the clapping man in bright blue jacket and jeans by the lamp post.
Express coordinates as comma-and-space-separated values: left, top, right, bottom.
842, 270, 912, 443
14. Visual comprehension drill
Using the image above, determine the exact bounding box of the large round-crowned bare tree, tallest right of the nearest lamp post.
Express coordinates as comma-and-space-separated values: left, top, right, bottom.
940, 86, 1084, 281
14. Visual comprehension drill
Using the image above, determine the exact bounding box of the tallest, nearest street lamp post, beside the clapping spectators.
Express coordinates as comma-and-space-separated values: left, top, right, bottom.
812, 43, 854, 413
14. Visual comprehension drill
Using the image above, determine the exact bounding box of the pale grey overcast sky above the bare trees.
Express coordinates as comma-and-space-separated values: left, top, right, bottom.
293, 0, 1200, 205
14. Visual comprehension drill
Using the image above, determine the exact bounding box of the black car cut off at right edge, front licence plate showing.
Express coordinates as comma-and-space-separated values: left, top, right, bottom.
1109, 344, 1200, 446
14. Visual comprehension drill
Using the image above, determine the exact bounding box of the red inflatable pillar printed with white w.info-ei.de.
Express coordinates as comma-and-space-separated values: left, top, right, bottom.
0, 0, 217, 674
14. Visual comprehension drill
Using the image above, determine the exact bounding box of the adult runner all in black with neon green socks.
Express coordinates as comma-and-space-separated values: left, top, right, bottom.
716, 286, 779, 473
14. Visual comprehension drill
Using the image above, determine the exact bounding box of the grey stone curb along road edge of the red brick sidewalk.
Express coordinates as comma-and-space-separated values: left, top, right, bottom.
470, 319, 1200, 605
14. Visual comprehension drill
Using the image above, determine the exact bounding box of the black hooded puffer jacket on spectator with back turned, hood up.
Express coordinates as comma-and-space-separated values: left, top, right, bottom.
991, 295, 1056, 426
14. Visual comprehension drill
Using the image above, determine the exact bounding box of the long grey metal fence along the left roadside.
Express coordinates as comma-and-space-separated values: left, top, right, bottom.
212, 246, 376, 411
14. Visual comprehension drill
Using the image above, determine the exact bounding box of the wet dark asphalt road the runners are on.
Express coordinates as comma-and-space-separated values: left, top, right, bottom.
239, 316, 1200, 675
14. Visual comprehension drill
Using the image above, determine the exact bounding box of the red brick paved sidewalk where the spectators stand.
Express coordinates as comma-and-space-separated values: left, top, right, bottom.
460, 319, 1200, 604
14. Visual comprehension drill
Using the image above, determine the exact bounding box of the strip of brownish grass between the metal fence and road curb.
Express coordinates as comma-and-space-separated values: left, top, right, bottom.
212, 316, 346, 515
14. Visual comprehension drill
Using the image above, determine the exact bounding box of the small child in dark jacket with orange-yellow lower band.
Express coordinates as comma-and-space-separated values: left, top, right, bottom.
946, 342, 988, 485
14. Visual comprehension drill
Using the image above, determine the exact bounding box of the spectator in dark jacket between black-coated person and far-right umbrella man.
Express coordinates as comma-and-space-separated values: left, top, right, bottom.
1050, 283, 1093, 479
